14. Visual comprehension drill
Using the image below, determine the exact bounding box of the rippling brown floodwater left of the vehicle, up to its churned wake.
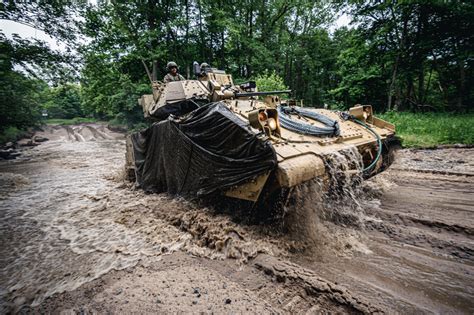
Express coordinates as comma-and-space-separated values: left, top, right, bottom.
0, 126, 281, 309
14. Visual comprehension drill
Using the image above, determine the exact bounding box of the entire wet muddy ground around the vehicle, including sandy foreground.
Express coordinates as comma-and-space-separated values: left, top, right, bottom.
0, 125, 474, 314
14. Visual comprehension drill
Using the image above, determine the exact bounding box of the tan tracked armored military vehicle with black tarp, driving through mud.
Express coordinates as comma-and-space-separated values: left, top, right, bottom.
127, 63, 395, 209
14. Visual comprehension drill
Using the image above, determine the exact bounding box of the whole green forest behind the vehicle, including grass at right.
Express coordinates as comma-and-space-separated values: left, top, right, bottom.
0, 0, 474, 145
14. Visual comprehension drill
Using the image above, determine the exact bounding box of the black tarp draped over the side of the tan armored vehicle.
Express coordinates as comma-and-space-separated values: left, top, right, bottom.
132, 103, 277, 196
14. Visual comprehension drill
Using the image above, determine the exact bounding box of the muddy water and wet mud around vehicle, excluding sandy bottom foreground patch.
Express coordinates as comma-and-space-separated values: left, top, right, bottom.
0, 125, 474, 313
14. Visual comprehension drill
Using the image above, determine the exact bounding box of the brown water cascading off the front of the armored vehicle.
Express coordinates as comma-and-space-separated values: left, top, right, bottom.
285, 147, 369, 256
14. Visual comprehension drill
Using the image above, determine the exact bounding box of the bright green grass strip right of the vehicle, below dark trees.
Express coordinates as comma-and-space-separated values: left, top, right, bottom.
378, 112, 474, 147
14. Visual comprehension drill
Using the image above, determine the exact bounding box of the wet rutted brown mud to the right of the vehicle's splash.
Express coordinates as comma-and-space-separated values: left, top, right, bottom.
293, 149, 474, 314
